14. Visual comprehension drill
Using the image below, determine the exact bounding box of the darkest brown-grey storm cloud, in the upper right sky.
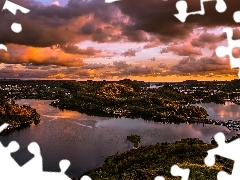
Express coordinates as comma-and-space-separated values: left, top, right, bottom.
116, 0, 240, 42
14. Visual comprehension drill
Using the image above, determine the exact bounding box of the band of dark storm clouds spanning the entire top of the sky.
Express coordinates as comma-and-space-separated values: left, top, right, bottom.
0, 0, 240, 48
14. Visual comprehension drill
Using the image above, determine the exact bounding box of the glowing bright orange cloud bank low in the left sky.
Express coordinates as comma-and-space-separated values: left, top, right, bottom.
0, 44, 109, 67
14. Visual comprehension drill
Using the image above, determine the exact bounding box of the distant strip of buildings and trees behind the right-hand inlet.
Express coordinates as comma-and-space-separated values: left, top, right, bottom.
148, 79, 240, 104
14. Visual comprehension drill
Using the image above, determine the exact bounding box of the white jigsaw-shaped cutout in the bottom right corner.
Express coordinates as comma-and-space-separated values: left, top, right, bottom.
204, 133, 240, 180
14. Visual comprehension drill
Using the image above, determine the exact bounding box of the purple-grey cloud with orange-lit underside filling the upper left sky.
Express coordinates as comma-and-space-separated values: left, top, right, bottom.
0, 0, 120, 47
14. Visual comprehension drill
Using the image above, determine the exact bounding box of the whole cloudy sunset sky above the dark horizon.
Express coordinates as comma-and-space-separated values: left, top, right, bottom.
0, 0, 240, 82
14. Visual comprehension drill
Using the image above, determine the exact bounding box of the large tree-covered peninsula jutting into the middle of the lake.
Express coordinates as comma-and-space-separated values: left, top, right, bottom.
51, 80, 208, 123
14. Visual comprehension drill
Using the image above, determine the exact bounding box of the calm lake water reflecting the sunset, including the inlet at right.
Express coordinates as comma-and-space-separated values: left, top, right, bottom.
0, 100, 240, 176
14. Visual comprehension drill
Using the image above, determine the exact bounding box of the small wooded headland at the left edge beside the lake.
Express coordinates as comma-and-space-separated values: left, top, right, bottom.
0, 92, 40, 134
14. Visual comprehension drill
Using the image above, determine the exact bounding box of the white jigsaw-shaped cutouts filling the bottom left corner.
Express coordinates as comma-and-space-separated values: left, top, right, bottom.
0, 123, 91, 180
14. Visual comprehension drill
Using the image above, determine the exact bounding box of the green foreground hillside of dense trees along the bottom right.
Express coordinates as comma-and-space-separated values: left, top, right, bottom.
84, 139, 233, 180
